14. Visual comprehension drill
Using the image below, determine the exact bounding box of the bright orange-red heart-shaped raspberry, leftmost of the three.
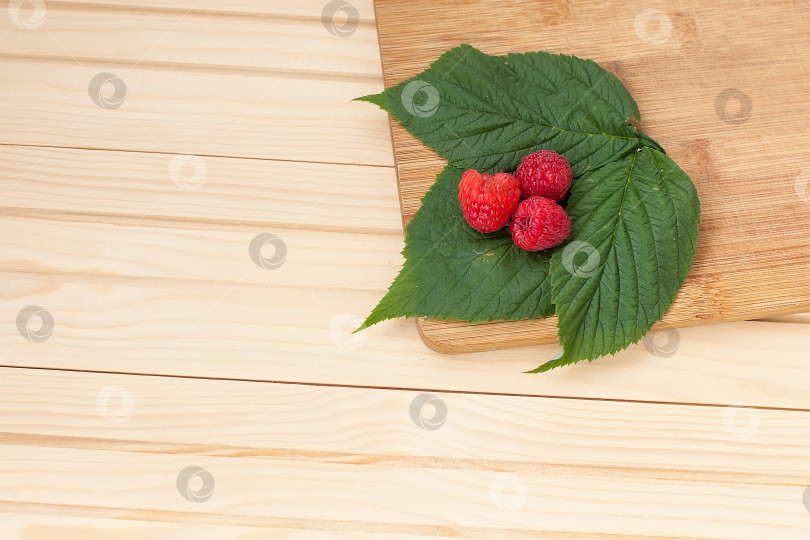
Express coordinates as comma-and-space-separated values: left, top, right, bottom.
458, 169, 520, 232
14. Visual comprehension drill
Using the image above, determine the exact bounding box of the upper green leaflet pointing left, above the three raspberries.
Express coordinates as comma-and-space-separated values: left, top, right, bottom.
359, 45, 644, 176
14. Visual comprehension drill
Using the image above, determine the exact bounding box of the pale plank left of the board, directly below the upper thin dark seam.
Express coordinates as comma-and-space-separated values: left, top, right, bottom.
0, 145, 402, 232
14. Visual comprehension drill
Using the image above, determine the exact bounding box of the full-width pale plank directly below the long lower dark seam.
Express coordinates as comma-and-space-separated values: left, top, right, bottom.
0, 368, 810, 485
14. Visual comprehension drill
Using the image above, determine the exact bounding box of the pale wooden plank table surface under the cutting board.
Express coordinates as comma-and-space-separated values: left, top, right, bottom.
0, 0, 810, 540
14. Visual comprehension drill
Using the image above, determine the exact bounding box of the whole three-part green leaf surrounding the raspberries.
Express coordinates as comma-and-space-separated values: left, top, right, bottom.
359, 45, 700, 372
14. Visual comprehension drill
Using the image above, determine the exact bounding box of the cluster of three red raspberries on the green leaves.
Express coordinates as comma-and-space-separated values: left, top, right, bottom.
458, 150, 574, 251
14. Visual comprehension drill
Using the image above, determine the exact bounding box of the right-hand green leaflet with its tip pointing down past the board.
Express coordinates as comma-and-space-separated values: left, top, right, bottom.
534, 147, 700, 372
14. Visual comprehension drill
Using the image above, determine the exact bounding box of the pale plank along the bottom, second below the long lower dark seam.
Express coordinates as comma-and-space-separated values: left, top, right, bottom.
0, 445, 810, 538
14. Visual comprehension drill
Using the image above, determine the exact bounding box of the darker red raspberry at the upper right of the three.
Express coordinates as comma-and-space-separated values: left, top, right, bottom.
515, 150, 574, 201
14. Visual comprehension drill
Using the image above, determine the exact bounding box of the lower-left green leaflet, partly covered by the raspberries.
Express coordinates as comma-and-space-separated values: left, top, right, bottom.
358, 166, 553, 330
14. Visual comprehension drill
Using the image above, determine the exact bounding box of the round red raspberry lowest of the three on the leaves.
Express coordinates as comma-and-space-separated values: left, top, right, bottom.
509, 197, 571, 251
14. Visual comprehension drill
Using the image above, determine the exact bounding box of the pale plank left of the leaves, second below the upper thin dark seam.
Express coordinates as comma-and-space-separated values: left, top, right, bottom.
0, 212, 402, 295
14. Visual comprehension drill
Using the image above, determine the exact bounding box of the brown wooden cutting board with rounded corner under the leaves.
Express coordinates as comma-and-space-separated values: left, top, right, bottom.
376, 0, 810, 353
